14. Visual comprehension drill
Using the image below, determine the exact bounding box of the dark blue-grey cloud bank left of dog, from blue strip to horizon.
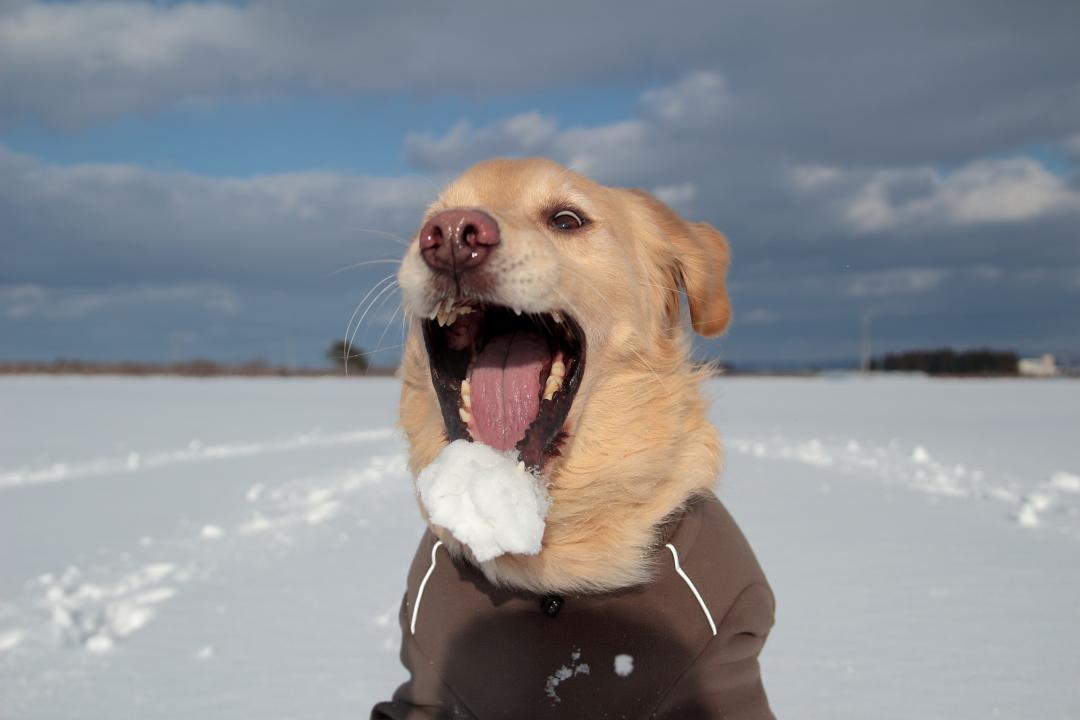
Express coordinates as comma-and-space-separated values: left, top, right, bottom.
0, 142, 436, 364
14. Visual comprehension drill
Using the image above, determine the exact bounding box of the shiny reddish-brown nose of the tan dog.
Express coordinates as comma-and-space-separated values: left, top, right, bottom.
420, 208, 499, 274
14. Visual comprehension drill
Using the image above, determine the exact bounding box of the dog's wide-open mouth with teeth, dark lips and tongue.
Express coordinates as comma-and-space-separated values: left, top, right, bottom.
423, 302, 585, 472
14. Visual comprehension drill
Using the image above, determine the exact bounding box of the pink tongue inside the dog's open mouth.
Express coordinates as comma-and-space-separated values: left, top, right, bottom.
469, 332, 551, 450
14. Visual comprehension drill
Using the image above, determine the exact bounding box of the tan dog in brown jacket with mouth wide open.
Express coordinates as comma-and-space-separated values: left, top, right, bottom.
372, 158, 774, 719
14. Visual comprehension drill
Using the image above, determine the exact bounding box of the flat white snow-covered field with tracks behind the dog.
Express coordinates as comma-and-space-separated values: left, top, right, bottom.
0, 378, 1080, 720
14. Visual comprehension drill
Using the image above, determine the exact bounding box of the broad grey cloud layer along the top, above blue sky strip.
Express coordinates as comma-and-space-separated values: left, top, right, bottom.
0, 0, 1080, 174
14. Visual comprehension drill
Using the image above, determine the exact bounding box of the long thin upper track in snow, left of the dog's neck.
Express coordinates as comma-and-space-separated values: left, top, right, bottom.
0, 427, 397, 490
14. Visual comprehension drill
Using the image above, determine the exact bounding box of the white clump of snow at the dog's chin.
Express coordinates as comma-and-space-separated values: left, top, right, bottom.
416, 440, 550, 562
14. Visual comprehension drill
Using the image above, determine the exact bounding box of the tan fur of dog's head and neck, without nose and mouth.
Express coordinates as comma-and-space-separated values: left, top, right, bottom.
399, 159, 730, 593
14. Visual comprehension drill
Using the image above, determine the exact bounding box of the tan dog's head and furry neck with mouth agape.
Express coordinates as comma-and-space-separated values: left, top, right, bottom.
399, 159, 730, 587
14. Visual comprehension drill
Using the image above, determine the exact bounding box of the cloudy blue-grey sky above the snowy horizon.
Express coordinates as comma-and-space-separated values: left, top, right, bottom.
0, 0, 1080, 367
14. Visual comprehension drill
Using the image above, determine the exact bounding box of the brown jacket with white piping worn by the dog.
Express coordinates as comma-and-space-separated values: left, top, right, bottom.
372, 495, 774, 720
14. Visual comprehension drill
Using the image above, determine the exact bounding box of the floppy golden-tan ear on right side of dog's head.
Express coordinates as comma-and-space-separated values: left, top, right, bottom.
633, 190, 731, 338
